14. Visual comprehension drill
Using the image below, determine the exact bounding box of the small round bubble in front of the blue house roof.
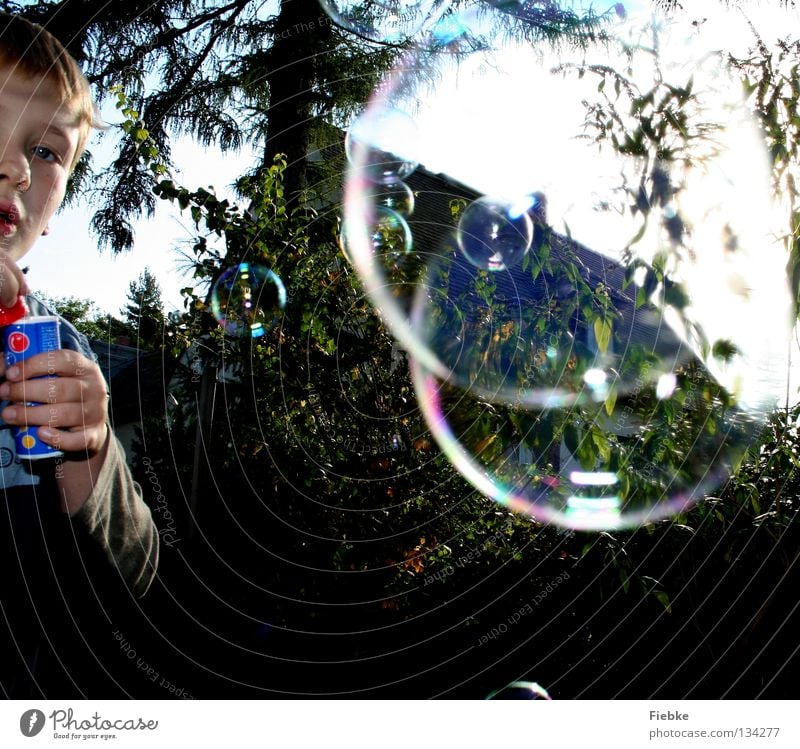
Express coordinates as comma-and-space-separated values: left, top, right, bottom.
457, 197, 533, 271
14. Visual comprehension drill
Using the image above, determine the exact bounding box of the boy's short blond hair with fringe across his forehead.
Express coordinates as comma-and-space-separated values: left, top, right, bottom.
0, 12, 102, 171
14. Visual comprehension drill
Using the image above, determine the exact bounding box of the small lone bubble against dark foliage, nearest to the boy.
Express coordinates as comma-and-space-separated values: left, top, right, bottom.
211, 263, 286, 338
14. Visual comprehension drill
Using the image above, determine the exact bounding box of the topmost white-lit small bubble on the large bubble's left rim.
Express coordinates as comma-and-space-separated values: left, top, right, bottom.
344, 108, 419, 185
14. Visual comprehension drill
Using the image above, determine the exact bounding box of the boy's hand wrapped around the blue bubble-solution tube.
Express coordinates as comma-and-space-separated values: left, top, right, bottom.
0, 349, 109, 456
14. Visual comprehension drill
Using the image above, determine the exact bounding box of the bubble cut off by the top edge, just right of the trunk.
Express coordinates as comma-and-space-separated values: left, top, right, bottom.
320, 0, 450, 44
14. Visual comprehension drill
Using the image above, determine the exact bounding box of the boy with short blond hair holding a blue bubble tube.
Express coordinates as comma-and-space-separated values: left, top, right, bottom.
0, 14, 158, 697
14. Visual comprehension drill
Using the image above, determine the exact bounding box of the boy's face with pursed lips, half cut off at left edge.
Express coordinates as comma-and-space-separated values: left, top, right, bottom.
0, 65, 80, 261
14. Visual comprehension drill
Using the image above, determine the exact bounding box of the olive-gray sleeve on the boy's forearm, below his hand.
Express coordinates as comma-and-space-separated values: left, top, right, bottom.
70, 433, 159, 598
